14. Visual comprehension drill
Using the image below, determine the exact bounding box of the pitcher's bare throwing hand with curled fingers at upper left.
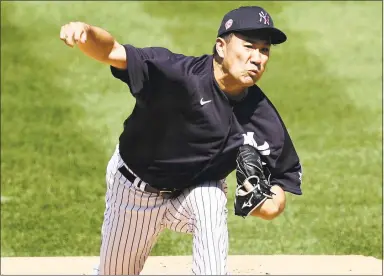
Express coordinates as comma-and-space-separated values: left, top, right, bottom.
60, 22, 90, 47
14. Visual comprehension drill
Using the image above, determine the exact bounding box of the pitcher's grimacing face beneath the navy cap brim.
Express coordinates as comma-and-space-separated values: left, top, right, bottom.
223, 34, 271, 87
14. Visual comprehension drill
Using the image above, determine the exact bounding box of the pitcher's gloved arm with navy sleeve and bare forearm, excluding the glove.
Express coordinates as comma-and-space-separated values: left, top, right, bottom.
234, 88, 302, 220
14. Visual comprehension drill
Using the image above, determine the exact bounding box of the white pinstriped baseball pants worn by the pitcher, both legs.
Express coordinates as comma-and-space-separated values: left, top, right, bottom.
99, 146, 228, 275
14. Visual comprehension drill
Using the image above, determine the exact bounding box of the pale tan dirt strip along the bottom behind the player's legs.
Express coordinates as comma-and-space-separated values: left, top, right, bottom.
1, 255, 383, 275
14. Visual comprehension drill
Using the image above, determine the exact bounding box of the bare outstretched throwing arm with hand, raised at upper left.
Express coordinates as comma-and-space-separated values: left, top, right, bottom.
60, 22, 127, 69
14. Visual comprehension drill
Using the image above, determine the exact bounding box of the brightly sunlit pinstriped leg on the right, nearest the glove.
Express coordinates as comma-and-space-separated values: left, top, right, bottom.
171, 181, 228, 275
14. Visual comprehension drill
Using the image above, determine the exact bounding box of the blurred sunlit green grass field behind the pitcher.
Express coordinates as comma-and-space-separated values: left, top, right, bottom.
1, 1, 383, 259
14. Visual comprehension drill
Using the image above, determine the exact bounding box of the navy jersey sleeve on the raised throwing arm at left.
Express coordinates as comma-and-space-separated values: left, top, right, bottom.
110, 44, 172, 97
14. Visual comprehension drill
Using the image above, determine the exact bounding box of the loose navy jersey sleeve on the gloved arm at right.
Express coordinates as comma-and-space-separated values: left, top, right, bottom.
240, 91, 302, 195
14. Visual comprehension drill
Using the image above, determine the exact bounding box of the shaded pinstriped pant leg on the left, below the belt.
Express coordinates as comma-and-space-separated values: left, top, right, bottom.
99, 147, 166, 275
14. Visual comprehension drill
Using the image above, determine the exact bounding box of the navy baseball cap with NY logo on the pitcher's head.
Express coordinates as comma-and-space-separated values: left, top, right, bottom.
217, 6, 287, 44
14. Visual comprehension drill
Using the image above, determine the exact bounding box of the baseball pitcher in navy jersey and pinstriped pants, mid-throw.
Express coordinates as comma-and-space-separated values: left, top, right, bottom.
60, 6, 301, 275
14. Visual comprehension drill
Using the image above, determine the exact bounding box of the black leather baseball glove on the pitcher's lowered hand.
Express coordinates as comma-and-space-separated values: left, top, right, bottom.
234, 145, 274, 218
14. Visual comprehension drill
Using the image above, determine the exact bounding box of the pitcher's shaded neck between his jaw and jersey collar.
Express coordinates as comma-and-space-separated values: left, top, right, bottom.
213, 58, 247, 96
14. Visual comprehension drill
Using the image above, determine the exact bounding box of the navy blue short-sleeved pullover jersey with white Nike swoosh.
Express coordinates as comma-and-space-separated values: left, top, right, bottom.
111, 44, 301, 194
